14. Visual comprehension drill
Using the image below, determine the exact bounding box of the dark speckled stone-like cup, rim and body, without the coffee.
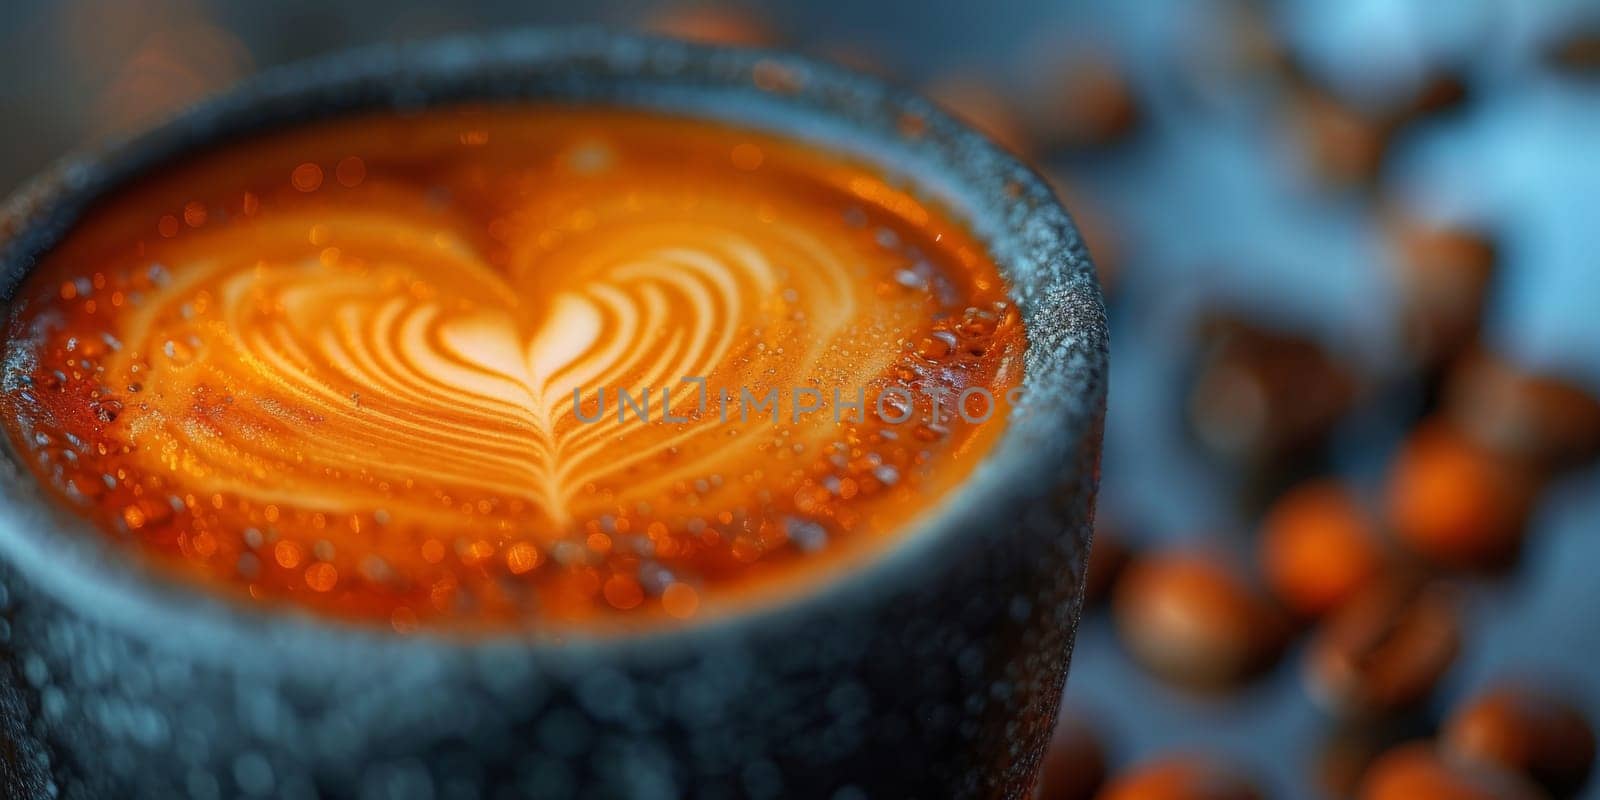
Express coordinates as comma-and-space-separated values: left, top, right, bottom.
0, 30, 1107, 798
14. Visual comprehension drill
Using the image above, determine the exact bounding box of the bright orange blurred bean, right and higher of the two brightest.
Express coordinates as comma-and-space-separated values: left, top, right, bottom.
1386, 421, 1538, 570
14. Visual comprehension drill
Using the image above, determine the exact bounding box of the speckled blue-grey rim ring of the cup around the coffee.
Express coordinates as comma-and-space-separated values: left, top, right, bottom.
0, 29, 1107, 669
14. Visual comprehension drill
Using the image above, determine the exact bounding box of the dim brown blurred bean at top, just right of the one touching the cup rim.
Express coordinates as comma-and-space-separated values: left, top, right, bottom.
1027, 50, 1141, 149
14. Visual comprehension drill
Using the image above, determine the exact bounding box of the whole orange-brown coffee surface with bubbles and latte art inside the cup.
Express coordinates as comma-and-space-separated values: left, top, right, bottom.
3, 106, 1024, 632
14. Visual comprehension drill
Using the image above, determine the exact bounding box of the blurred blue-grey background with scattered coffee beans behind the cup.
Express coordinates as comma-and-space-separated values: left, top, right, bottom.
0, 0, 1600, 800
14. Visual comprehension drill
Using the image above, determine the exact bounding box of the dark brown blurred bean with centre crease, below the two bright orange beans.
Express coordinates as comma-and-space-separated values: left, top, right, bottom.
1304, 578, 1461, 717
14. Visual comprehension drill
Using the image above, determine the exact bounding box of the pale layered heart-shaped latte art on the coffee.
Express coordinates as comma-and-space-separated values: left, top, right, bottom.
118, 200, 910, 530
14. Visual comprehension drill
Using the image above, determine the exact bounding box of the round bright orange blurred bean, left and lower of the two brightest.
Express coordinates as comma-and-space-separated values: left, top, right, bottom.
1259, 480, 1384, 618
